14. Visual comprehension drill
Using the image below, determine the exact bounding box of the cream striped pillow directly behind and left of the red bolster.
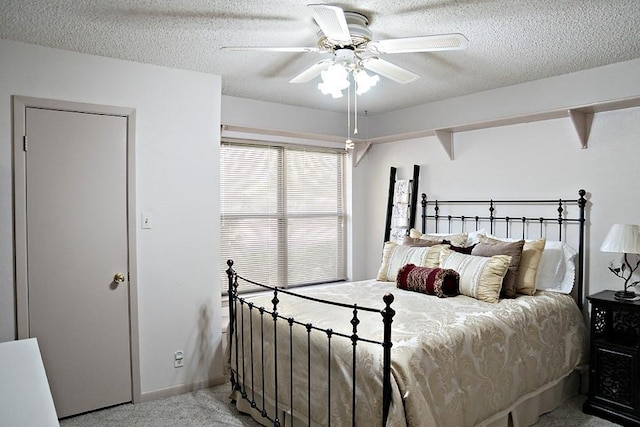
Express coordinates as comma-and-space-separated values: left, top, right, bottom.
377, 242, 443, 282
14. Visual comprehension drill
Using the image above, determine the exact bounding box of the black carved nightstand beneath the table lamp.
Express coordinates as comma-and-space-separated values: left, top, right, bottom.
583, 291, 640, 426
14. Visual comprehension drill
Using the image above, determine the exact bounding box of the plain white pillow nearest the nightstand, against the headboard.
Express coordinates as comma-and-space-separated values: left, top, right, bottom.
536, 241, 578, 294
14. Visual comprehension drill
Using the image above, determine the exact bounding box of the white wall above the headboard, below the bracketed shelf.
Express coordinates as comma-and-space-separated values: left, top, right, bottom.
353, 107, 640, 294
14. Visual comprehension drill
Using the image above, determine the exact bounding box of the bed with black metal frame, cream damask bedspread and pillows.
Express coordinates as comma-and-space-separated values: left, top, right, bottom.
227, 190, 588, 426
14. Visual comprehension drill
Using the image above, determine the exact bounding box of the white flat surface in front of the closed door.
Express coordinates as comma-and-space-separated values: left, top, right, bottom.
0, 338, 60, 427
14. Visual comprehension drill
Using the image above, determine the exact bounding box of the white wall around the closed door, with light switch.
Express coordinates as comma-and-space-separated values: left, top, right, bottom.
0, 40, 222, 395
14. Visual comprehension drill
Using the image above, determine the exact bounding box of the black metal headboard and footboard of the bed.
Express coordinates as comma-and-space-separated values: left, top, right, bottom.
227, 190, 587, 427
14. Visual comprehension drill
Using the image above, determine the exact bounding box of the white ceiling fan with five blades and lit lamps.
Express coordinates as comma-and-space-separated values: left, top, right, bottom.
222, 4, 468, 93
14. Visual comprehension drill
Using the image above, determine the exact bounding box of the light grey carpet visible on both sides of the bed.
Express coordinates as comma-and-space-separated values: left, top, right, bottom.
60, 384, 616, 427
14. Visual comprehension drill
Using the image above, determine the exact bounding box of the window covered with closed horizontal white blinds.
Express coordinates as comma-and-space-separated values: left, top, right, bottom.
220, 142, 346, 293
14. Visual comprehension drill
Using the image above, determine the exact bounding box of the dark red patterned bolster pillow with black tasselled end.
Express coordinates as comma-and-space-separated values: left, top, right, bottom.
396, 264, 460, 298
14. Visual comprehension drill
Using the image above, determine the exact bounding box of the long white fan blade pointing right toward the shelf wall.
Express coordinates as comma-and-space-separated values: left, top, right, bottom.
367, 33, 469, 54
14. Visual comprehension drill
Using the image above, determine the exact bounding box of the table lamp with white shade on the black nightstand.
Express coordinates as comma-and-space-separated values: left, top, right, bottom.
600, 224, 640, 299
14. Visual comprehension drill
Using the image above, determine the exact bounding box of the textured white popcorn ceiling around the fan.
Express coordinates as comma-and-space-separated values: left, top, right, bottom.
0, 0, 640, 114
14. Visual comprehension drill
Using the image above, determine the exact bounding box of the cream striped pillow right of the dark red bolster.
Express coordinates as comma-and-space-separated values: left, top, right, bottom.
440, 248, 511, 303
